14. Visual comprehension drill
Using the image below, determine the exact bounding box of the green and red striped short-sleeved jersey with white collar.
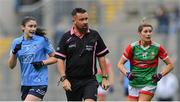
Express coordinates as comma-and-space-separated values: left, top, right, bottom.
122, 41, 168, 87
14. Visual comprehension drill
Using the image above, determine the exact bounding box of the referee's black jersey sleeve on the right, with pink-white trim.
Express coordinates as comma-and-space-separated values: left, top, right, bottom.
96, 33, 109, 57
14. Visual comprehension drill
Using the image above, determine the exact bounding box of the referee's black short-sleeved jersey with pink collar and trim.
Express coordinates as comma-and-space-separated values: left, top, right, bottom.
55, 29, 109, 78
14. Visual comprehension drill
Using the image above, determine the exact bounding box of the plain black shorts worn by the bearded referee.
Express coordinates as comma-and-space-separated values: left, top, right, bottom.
66, 77, 98, 101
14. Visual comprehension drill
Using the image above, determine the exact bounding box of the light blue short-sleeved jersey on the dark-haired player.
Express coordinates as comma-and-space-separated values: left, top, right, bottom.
11, 35, 54, 86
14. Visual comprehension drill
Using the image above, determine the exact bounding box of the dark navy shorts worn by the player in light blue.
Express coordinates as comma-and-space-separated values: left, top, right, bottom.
21, 85, 48, 101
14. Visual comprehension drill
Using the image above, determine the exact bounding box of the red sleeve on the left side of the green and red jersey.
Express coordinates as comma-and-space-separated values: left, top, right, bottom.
122, 45, 133, 60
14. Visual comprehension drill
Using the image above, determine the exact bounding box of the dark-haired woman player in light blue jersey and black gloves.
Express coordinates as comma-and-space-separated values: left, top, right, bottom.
8, 17, 56, 101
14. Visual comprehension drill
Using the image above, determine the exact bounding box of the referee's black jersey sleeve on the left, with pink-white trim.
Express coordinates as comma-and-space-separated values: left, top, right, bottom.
55, 34, 67, 60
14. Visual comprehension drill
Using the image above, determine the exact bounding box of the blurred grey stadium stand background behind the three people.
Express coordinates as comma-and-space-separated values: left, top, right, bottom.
0, 0, 180, 101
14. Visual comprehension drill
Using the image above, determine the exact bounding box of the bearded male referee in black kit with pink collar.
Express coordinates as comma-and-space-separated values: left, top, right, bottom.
55, 8, 109, 101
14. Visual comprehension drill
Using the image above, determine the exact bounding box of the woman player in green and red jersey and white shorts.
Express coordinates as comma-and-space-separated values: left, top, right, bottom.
118, 23, 173, 101
